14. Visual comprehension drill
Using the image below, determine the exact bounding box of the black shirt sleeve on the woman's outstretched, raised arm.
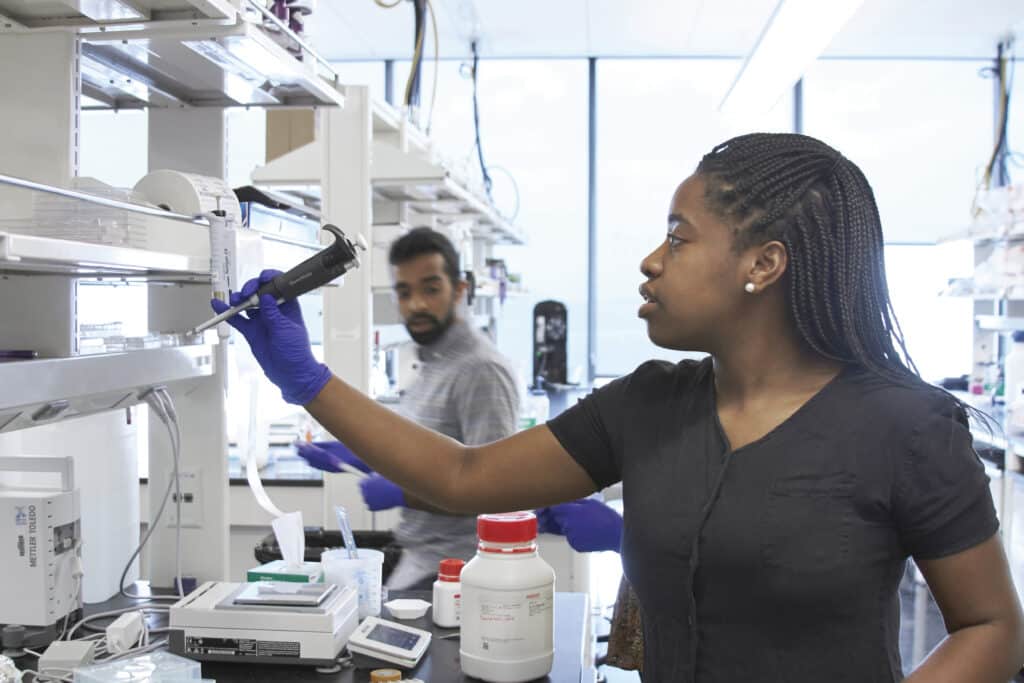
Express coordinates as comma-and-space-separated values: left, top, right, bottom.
548, 374, 633, 488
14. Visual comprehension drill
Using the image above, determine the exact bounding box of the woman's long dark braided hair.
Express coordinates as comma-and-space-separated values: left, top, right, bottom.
697, 133, 922, 386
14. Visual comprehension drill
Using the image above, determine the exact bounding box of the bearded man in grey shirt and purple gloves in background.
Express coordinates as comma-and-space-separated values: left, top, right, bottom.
298, 227, 519, 590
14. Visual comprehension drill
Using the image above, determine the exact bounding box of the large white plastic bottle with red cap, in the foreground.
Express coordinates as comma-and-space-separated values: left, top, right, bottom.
459, 512, 555, 683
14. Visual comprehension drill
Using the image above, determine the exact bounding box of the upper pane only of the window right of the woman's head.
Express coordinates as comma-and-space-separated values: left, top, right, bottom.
804, 59, 993, 244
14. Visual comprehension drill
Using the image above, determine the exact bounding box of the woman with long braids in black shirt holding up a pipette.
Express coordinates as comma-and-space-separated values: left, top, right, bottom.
211, 134, 1024, 683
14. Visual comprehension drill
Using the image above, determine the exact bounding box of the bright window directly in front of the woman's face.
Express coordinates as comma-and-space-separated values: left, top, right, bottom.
596, 59, 793, 375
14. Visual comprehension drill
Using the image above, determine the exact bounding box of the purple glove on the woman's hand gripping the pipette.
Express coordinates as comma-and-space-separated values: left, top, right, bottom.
210, 270, 331, 405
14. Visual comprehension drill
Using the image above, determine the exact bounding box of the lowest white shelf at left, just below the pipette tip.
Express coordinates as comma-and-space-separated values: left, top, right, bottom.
0, 344, 214, 431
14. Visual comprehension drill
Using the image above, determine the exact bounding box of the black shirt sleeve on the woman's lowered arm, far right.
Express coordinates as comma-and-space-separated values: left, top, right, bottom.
893, 397, 998, 559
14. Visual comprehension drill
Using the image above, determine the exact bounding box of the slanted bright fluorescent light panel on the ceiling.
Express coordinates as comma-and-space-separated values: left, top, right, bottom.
719, 0, 863, 114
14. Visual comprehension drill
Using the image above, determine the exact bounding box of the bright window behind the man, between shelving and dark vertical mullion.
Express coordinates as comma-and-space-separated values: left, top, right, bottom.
395, 59, 588, 389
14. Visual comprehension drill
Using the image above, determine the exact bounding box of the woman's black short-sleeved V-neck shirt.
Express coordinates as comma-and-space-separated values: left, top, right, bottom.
548, 358, 998, 683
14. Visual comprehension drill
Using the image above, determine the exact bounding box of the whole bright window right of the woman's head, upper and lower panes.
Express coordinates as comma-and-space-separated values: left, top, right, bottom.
804, 59, 993, 380
